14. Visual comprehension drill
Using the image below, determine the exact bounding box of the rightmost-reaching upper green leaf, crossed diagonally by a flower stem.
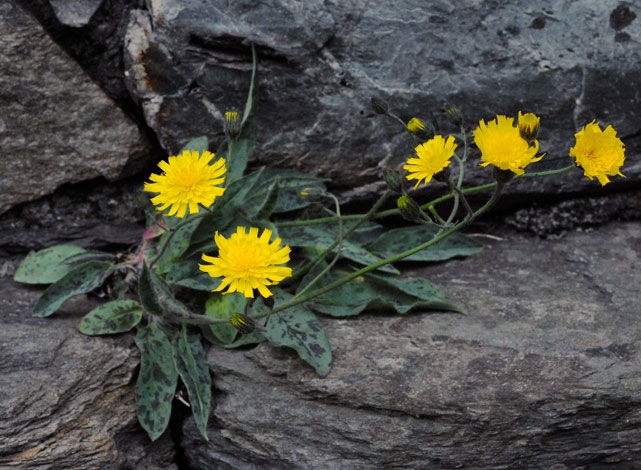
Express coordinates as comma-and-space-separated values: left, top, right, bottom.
366, 225, 483, 261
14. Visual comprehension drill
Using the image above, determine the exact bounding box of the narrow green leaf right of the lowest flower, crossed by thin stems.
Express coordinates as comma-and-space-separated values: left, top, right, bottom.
279, 224, 400, 274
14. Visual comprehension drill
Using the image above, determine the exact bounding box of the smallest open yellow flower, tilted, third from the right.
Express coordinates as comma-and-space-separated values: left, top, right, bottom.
403, 135, 457, 189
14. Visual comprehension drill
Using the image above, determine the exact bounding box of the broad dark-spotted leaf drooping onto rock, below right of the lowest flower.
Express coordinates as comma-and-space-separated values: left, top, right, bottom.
264, 289, 332, 377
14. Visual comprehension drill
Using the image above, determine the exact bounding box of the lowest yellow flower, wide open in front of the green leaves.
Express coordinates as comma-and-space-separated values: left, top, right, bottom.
199, 227, 292, 297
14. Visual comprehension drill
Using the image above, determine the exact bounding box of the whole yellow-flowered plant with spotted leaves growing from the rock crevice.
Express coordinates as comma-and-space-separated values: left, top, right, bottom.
15, 48, 625, 440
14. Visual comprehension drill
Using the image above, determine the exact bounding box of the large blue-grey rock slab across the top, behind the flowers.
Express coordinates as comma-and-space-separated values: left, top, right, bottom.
125, 0, 641, 197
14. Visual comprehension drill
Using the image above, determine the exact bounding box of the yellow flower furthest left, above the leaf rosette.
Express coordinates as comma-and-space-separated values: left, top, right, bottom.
145, 150, 227, 217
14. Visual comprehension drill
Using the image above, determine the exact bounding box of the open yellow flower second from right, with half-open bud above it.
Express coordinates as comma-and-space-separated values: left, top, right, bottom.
474, 116, 543, 175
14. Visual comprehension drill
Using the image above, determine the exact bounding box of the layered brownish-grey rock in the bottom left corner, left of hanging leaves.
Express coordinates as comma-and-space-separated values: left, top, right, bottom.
0, 277, 177, 470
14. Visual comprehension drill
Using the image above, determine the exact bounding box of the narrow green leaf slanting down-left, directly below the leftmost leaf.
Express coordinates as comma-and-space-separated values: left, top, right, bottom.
33, 261, 113, 317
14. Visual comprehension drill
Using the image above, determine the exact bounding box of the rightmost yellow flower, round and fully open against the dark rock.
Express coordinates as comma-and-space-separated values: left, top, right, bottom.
570, 121, 625, 186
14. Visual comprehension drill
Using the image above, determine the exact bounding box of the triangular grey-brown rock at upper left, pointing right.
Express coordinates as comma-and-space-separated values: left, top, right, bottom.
0, 0, 147, 213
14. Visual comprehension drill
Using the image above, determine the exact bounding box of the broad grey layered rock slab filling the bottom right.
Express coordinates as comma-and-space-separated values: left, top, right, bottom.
182, 222, 641, 470
